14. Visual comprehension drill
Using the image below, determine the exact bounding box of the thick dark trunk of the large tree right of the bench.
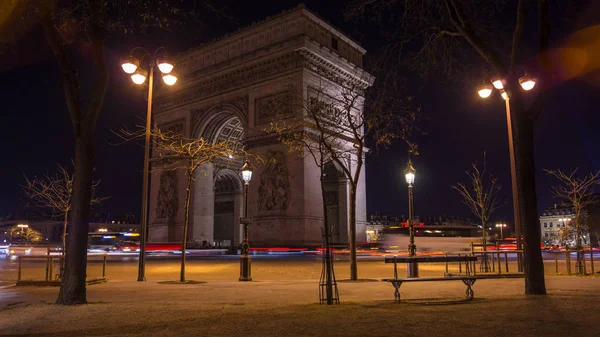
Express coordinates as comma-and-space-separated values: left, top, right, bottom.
509, 93, 546, 295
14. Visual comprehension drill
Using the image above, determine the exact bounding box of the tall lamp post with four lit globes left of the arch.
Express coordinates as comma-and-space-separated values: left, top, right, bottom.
121, 47, 177, 282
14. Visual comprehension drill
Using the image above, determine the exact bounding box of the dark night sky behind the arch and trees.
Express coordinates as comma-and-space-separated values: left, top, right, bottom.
0, 0, 600, 228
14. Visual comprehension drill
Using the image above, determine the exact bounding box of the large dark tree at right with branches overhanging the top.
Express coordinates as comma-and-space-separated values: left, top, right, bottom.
348, 0, 572, 294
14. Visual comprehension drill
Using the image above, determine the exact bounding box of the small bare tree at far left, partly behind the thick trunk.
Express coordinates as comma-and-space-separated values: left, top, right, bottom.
21, 165, 108, 277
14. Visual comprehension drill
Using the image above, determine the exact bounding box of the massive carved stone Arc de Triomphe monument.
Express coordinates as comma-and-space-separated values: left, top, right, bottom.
148, 7, 366, 247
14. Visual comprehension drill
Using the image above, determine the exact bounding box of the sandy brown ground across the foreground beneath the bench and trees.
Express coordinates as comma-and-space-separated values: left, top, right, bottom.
0, 276, 600, 337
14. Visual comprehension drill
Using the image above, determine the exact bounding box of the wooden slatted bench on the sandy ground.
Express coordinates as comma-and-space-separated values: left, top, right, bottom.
382, 255, 480, 301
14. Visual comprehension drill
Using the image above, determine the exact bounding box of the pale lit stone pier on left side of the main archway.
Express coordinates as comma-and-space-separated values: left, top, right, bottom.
192, 163, 215, 244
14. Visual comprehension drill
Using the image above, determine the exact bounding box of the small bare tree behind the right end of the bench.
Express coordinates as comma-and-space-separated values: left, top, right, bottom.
452, 153, 501, 271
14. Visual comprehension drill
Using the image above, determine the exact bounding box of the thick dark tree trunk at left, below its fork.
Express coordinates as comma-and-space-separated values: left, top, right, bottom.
56, 134, 96, 305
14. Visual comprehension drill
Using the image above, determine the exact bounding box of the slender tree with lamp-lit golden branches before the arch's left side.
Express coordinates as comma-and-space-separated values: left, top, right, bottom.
119, 126, 253, 283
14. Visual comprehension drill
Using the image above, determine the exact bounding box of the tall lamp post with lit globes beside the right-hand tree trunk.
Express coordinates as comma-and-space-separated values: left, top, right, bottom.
477, 74, 536, 271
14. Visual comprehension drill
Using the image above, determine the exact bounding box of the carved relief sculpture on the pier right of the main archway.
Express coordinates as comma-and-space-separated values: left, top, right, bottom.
258, 151, 290, 211
